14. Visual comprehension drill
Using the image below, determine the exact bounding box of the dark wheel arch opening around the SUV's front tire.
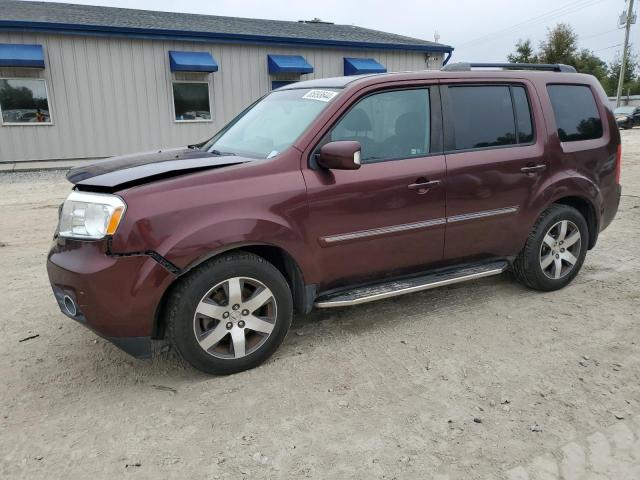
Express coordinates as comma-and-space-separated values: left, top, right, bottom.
151, 243, 316, 339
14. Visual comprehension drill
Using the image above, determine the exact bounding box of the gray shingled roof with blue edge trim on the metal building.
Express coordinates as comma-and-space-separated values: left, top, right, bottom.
0, 0, 453, 52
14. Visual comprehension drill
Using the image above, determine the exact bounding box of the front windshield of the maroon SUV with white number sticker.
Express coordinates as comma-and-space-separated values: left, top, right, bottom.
202, 88, 338, 158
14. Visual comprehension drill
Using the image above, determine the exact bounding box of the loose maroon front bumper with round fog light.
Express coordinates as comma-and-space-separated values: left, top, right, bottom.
47, 239, 174, 358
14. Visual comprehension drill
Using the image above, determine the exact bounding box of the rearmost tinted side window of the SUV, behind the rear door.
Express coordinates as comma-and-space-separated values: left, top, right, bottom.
547, 85, 602, 142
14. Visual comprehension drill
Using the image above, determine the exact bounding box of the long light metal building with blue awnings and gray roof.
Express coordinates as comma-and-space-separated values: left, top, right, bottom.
0, 0, 453, 162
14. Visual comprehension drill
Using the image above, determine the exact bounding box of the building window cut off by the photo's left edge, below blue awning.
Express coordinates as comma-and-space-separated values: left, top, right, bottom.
0, 78, 51, 125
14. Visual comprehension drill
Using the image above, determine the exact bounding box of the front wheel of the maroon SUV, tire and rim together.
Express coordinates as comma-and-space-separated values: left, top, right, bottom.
166, 252, 293, 375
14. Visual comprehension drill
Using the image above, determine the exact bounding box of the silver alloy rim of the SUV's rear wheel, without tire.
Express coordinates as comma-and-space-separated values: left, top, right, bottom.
540, 220, 582, 280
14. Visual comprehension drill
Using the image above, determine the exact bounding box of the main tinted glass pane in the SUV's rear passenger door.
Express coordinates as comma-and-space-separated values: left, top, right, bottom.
449, 85, 516, 150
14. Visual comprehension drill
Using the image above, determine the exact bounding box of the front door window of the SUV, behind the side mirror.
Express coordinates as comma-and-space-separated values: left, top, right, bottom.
326, 89, 431, 163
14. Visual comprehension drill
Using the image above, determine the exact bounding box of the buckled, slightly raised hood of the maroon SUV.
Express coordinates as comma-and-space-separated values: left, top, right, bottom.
67, 147, 251, 191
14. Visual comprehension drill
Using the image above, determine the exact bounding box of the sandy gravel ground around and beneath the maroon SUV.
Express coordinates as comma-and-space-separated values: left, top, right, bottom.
0, 129, 640, 480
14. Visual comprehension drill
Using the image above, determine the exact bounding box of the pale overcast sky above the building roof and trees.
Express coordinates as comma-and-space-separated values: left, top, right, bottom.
37, 0, 640, 62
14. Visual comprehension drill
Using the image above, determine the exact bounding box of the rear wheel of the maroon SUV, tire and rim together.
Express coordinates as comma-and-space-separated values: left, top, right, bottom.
512, 204, 589, 292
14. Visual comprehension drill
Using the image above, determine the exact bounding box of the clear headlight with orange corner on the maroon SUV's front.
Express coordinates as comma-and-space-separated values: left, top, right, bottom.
58, 190, 127, 240
